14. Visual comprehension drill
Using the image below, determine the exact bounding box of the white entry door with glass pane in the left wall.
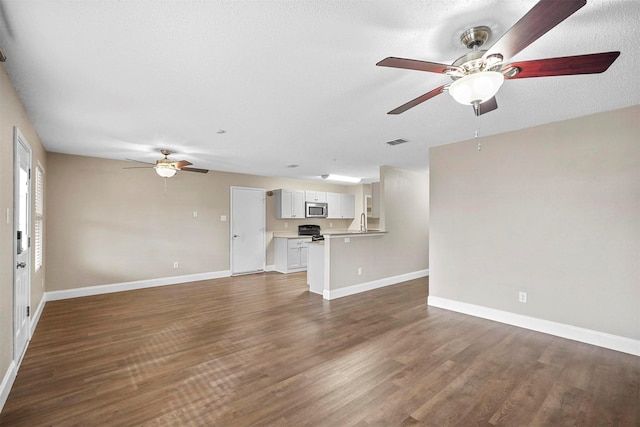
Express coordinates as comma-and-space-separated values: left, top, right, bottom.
13, 128, 31, 361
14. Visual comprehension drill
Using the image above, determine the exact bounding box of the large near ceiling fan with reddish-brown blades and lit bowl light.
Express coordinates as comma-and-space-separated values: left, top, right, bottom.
376, 0, 620, 116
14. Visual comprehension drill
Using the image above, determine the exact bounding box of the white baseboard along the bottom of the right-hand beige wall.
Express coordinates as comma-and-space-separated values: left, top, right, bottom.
427, 296, 640, 356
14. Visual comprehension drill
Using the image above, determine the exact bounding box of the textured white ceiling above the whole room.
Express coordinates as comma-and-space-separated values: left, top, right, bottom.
0, 0, 640, 181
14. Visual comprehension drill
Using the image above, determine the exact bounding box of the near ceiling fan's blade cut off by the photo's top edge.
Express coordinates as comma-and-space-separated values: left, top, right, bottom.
482, 0, 587, 59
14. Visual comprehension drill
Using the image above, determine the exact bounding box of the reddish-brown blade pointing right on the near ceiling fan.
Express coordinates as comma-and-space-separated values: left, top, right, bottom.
503, 52, 620, 80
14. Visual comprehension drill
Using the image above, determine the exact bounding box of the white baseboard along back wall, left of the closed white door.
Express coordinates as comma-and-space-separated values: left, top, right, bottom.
46, 270, 231, 301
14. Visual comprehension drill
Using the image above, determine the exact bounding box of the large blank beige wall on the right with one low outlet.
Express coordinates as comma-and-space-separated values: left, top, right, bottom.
429, 106, 640, 339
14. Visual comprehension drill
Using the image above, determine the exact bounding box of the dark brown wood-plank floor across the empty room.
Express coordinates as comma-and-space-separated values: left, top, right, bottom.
0, 273, 640, 426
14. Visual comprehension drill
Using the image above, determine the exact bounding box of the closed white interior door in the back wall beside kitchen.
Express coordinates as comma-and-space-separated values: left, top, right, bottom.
231, 187, 266, 274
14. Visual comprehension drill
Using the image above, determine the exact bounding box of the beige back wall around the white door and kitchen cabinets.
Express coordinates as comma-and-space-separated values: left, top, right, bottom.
46, 153, 363, 291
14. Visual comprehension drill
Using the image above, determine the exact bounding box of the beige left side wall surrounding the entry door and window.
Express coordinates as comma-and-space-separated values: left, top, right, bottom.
0, 65, 47, 380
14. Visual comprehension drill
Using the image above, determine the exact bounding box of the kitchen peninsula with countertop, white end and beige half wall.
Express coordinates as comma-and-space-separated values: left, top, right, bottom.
307, 231, 386, 299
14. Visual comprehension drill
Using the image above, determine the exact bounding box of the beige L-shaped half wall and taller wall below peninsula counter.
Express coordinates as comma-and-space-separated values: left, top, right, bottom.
330, 166, 429, 290
